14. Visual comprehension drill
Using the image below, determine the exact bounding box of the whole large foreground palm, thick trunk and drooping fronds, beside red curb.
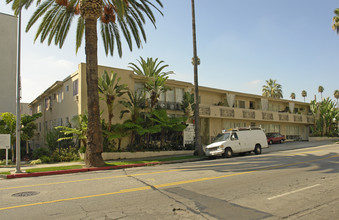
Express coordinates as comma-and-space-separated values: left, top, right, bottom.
6, 0, 162, 167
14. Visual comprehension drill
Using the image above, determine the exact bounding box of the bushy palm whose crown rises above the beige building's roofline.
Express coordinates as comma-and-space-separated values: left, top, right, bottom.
129, 57, 171, 111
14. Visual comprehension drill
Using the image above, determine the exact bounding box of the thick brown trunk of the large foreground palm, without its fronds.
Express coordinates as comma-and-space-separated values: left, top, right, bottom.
85, 17, 104, 167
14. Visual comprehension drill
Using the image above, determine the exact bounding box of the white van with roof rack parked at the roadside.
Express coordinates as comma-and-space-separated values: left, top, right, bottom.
205, 128, 268, 157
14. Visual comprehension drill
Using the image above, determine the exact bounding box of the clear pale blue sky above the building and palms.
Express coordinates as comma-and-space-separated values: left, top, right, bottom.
0, 0, 339, 102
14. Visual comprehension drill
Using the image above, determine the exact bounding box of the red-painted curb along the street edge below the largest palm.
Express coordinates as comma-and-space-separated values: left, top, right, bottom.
4, 162, 166, 179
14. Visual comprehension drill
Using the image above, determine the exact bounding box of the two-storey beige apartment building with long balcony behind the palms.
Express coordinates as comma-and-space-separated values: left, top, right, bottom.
30, 63, 314, 148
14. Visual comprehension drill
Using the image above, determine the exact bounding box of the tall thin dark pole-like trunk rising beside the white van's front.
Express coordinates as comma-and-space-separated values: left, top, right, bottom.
191, 0, 204, 156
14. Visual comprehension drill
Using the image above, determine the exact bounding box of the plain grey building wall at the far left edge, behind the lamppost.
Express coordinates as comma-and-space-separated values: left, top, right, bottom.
0, 13, 17, 114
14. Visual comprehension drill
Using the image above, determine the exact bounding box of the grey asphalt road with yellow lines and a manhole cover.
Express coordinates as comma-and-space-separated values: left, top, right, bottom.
0, 142, 339, 220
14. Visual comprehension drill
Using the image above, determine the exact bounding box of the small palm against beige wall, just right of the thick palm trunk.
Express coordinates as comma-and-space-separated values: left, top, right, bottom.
98, 71, 128, 132
